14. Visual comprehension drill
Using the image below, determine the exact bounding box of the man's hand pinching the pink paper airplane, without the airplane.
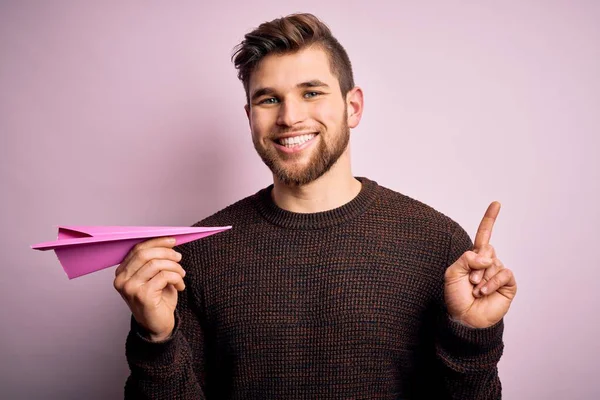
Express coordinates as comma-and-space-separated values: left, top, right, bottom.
114, 238, 185, 341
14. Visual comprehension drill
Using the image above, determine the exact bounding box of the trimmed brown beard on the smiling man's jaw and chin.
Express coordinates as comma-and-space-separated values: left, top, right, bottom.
252, 108, 350, 186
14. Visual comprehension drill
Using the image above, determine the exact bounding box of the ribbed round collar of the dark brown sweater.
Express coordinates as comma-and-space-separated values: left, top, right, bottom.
252, 177, 379, 229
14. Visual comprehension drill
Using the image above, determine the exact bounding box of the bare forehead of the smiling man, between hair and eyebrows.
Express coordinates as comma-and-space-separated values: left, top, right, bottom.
250, 47, 338, 93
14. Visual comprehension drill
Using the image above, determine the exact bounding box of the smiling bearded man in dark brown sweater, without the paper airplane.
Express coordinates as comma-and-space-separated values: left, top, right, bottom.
115, 14, 516, 399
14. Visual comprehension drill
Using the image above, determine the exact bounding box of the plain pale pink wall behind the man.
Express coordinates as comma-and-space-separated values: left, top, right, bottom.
0, 0, 600, 399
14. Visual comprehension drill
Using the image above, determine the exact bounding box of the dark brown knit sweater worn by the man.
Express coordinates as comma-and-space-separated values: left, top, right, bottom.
125, 178, 503, 400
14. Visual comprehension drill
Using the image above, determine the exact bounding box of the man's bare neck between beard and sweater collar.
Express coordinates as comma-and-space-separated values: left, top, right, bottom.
272, 149, 361, 213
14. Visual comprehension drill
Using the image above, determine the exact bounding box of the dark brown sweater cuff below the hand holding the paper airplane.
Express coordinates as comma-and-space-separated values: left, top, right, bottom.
125, 311, 180, 368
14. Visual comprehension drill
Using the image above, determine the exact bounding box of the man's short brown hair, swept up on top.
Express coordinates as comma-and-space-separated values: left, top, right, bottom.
231, 13, 354, 104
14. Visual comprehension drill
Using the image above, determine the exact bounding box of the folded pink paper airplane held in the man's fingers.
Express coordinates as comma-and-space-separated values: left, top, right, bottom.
31, 226, 231, 279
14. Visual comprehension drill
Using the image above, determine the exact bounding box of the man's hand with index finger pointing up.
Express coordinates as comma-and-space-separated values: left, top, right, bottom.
444, 202, 517, 328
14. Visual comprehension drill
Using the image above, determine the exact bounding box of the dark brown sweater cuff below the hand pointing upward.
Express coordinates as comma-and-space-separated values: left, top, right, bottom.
438, 316, 504, 371
